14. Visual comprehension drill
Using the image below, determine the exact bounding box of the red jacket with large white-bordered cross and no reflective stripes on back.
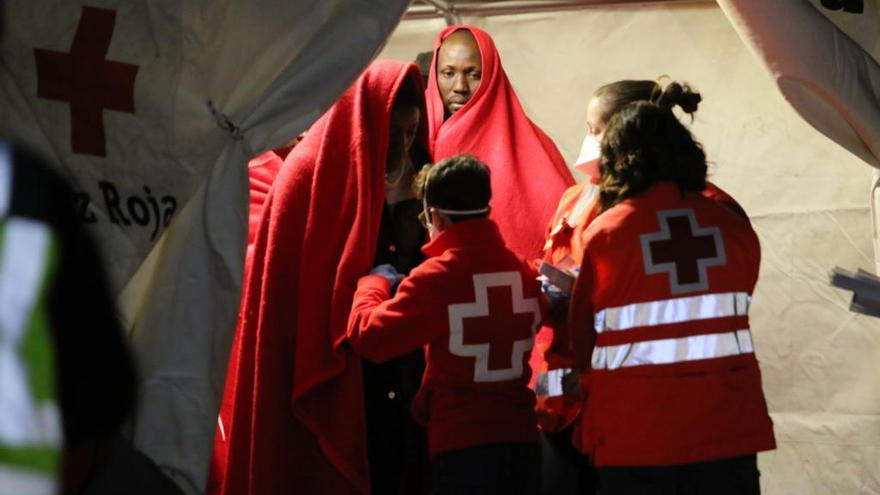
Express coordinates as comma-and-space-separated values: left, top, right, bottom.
348, 220, 541, 455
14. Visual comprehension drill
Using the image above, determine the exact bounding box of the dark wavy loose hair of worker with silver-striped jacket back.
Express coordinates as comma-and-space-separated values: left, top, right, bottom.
599, 101, 707, 211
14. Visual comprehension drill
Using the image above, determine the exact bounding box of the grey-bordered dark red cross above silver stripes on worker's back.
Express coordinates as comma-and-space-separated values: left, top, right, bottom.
641, 209, 727, 294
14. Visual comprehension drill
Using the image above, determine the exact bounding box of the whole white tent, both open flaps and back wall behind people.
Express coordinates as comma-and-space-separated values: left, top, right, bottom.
6, 0, 880, 494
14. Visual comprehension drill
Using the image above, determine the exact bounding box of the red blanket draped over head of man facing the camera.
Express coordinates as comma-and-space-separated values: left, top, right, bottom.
425, 26, 574, 259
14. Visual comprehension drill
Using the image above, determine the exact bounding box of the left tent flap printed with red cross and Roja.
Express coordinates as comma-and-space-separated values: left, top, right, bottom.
0, 0, 409, 493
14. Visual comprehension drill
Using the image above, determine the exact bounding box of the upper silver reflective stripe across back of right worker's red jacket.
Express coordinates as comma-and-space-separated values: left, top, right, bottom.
594, 292, 751, 333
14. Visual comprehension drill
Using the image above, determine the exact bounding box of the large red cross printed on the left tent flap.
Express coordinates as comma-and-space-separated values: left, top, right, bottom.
34, 7, 138, 156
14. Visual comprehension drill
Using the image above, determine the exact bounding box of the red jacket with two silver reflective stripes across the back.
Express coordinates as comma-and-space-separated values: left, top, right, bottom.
569, 183, 775, 466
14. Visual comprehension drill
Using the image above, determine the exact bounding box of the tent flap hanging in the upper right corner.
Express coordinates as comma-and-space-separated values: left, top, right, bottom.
719, 0, 880, 167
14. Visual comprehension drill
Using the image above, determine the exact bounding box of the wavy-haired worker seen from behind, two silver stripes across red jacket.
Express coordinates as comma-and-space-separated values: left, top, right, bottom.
568, 102, 775, 495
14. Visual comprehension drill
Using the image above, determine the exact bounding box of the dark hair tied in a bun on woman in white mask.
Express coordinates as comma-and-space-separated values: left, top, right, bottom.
593, 76, 703, 123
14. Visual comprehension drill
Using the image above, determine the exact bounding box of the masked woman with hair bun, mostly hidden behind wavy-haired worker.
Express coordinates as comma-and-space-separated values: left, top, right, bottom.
530, 78, 749, 494
